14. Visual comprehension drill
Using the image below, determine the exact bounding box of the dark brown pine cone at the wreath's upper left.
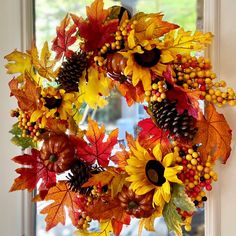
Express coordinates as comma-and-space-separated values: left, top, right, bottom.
58, 52, 87, 92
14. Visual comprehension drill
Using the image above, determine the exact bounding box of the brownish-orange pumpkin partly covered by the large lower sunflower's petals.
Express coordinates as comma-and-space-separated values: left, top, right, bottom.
118, 186, 154, 218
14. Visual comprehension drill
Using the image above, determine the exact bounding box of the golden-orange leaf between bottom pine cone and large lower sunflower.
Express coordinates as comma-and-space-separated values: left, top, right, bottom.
82, 167, 127, 198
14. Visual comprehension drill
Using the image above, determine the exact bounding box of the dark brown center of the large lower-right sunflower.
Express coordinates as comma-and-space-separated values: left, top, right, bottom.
145, 160, 166, 186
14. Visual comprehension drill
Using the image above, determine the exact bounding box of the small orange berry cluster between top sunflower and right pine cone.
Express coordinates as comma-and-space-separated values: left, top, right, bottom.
145, 80, 167, 102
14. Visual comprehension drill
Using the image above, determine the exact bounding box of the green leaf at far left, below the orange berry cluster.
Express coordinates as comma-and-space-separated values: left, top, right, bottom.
9, 122, 37, 149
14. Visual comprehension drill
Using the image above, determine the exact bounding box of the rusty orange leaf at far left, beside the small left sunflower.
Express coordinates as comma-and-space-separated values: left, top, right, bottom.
9, 74, 40, 111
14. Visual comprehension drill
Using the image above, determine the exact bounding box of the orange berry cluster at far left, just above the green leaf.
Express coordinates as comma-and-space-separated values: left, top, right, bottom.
11, 110, 44, 142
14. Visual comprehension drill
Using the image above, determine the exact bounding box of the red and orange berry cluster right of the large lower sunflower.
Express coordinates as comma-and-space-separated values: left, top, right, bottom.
175, 146, 217, 207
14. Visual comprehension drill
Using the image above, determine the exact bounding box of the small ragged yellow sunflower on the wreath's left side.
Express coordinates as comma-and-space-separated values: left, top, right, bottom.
30, 87, 79, 127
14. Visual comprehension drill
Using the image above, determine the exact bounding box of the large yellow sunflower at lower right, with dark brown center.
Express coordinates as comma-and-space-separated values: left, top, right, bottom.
125, 141, 183, 208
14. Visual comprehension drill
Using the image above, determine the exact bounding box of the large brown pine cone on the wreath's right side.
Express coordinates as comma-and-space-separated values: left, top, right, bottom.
150, 100, 197, 140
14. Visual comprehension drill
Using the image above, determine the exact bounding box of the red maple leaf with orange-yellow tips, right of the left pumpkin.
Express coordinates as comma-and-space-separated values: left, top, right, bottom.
77, 119, 118, 167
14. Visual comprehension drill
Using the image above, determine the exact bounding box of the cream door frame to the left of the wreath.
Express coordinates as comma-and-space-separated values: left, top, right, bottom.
0, 0, 33, 236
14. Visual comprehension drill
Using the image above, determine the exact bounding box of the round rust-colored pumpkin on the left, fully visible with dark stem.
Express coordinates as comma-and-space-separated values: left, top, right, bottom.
40, 134, 75, 173
